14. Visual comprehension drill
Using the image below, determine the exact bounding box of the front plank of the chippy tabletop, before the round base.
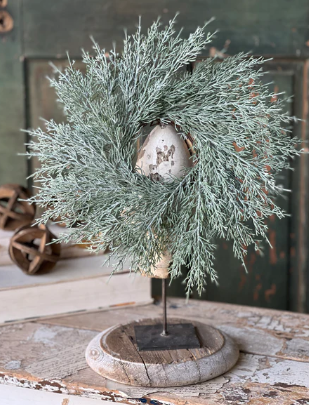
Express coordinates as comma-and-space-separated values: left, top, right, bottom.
0, 354, 309, 405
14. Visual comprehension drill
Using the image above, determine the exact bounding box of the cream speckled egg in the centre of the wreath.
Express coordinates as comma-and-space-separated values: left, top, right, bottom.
136, 125, 192, 182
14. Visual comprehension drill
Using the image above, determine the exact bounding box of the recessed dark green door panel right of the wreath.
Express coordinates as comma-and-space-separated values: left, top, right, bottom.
190, 62, 295, 309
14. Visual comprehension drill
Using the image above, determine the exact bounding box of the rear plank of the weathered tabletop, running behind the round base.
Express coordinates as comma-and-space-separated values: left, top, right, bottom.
40, 298, 309, 362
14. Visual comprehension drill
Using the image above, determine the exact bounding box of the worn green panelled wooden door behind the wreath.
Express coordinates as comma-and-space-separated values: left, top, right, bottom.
0, 0, 309, 312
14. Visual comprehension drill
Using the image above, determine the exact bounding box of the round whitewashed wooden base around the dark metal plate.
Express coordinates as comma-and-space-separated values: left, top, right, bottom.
86, 319, 239, 387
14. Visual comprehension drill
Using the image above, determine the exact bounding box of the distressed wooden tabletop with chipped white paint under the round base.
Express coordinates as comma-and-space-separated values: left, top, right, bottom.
0, 299, 309, 405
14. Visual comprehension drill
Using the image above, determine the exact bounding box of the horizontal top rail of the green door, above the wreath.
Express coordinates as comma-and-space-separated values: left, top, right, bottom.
23, 0, 309, 58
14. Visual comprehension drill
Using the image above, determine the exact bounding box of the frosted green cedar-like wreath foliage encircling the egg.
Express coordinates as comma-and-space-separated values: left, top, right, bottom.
28, 16, 299, 293
